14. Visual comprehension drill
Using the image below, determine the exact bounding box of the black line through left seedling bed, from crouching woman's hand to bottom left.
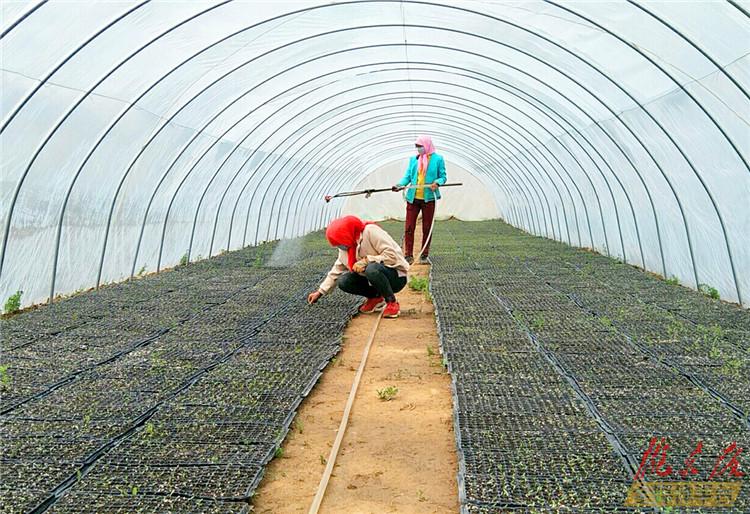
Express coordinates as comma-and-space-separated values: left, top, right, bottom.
30, 286, 318, 514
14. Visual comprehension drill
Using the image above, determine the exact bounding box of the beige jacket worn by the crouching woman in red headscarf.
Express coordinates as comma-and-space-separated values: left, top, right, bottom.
318, 225, 409, 294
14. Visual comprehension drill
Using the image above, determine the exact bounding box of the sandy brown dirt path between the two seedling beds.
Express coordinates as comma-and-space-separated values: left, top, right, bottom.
253, 224, 458, 514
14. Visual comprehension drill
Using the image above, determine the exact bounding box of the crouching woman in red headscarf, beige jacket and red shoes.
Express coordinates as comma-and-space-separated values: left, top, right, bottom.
307, 216, 409, 318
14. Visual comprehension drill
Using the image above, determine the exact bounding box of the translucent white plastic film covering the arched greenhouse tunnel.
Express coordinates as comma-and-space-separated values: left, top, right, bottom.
0, 0, 750, 306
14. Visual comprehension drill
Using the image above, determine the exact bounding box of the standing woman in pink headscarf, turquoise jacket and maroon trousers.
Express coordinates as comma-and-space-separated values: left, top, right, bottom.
392, 136, 447, 264
